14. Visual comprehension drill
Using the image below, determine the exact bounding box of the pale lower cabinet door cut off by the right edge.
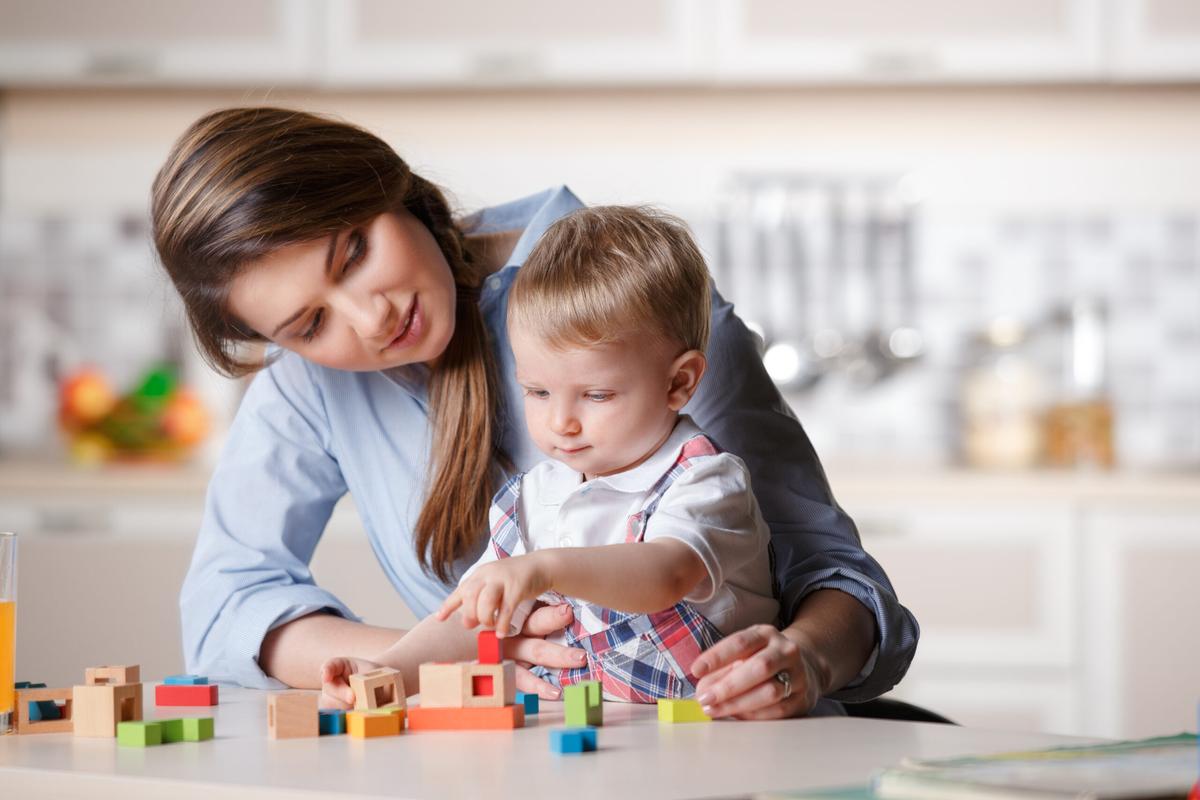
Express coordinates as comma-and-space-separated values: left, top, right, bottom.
1082, 507, 1200, 738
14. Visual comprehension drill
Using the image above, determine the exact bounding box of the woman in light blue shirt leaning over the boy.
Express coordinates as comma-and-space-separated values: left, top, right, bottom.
152, 108, 917, 718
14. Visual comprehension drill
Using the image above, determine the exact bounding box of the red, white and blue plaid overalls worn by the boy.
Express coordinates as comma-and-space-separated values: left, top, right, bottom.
491, 435, 721, 703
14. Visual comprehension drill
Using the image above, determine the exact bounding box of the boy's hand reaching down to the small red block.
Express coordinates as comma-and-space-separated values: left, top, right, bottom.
434, 552, 552, 638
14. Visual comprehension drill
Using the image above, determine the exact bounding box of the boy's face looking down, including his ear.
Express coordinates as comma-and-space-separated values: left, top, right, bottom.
510, 330, 703, 480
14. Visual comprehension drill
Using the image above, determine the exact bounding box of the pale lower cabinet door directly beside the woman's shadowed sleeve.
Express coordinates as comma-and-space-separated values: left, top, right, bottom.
845, 501, 1076, 668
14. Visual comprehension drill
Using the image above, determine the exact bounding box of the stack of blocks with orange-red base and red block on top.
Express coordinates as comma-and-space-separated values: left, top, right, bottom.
408, 631, 526, 730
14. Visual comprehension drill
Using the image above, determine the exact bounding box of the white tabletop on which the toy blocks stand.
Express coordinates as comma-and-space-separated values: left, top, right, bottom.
0, 684, 1104, 800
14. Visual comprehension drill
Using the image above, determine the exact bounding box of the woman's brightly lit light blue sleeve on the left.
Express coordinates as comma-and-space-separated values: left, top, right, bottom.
180, 354, 358, 688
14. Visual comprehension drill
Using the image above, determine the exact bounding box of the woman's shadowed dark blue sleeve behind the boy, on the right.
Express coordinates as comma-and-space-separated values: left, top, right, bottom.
685, 290, 919, 702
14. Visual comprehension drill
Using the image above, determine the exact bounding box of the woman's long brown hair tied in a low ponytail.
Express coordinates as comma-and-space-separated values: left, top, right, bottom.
151, 108, 503, 581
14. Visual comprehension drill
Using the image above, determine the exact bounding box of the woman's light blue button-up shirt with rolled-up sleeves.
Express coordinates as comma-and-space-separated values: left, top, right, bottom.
180, 187, 918, 700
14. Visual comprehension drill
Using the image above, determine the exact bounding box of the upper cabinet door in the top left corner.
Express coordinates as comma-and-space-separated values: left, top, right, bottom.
0, 0, 318, 85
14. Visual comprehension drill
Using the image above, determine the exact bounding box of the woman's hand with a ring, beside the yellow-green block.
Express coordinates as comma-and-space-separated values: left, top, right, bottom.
692, 625, 826, 720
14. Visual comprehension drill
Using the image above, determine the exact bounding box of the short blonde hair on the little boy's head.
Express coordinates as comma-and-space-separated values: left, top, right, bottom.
509, 205, 712, 351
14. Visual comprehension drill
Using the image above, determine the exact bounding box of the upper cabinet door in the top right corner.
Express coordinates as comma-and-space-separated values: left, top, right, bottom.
1111, 0, 1200, 80
